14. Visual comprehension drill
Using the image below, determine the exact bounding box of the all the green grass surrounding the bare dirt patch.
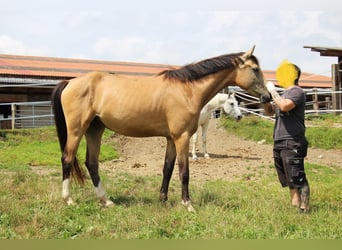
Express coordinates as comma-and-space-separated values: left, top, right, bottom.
0, 118, 342, 239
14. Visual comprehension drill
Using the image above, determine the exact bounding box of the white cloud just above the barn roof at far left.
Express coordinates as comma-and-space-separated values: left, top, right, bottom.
0, 35, 49, 56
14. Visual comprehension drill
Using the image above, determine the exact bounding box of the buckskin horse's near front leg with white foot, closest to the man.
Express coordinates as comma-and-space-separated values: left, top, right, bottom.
175, 136, 195, 212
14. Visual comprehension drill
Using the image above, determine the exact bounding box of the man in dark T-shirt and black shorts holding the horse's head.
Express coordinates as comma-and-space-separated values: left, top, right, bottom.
265, 60, 310, 213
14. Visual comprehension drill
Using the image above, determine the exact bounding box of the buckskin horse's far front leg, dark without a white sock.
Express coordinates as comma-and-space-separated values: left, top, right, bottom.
159, 138, 176, 202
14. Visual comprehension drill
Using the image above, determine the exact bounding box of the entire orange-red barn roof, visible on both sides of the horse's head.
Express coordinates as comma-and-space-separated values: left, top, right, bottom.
0, 54, 331, 88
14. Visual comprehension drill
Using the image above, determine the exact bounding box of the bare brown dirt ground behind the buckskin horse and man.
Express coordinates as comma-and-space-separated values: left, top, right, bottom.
102, 119, 342, 181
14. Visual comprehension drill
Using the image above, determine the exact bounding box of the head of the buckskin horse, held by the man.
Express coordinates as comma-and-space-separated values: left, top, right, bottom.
235, 46, 270, 103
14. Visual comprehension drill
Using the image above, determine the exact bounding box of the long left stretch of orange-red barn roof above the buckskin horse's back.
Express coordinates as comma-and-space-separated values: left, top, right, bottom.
0, 54, 170, 78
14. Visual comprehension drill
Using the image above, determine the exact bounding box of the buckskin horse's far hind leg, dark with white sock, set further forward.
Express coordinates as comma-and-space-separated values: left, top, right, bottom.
85, 118, 113, 207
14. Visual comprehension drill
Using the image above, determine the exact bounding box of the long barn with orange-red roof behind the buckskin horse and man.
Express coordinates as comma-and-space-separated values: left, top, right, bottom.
0, 54, 332, 129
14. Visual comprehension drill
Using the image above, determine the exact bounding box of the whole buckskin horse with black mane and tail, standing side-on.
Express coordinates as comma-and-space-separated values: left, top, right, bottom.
51, 47, 270, 212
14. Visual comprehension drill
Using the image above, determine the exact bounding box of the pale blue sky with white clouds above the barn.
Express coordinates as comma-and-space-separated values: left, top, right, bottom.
0, 0, 342, 76
